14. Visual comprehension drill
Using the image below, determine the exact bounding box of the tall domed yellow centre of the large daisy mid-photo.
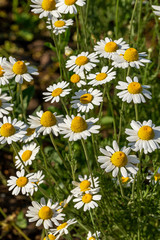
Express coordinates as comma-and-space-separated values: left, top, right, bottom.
71, 116, 87, 133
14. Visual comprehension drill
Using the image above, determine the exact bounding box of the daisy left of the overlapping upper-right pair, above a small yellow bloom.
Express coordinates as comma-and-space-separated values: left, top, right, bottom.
66, 52, 99, 74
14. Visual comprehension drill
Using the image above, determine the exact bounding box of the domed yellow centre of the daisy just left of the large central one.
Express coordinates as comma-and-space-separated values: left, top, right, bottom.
40, 111, 57, 127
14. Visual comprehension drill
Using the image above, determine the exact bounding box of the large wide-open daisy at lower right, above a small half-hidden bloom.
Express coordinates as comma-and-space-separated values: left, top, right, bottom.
98, 141, 139, 178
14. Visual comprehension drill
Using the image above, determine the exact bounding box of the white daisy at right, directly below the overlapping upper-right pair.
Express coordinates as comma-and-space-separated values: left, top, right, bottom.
116, 77, 152, 104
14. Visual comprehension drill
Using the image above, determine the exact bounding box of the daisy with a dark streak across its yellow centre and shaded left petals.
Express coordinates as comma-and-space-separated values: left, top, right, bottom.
71, 88, 103, 112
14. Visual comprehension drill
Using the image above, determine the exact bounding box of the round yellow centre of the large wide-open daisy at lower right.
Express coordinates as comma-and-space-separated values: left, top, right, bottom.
111, 151, 128, 167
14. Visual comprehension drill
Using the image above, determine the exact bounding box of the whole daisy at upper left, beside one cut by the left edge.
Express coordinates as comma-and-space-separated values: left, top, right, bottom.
4, 57, 39, 84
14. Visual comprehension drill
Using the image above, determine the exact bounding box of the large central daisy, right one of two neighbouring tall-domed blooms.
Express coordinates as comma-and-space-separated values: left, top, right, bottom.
59, 114, 100, 141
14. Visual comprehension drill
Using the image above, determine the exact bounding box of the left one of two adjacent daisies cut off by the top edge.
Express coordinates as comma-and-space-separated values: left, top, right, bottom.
30, 0, 61, 18
